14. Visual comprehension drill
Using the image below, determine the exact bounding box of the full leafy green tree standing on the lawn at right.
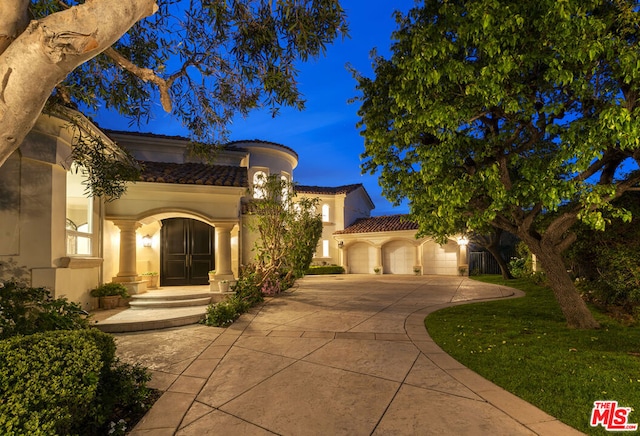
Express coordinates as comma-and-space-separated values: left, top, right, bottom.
355, 0, 640, 329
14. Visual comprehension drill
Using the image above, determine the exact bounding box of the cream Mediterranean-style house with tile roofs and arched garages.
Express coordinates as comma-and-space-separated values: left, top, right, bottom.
0, 113, 467, 309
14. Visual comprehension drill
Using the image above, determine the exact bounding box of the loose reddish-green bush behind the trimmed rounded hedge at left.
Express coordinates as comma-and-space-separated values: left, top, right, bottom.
0, 282, 89, 339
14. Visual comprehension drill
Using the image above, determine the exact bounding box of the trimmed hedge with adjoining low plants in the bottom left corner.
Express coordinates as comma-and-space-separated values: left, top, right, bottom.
0, 329, 150, 435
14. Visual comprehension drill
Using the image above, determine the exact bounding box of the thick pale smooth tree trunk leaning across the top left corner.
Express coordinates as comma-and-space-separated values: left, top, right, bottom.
0, 0, 157, 166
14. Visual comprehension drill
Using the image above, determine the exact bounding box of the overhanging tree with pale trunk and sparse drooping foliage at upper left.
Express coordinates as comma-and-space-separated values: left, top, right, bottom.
0, 0, 346, 194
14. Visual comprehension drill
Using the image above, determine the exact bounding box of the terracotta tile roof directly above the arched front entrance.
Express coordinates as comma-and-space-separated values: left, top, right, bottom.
140, 161, 249, 188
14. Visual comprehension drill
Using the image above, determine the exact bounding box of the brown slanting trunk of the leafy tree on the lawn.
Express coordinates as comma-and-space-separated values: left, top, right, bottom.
529, 244, 600, 330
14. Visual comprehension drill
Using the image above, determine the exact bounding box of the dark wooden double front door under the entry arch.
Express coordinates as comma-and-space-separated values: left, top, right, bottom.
160, 218, 215, 286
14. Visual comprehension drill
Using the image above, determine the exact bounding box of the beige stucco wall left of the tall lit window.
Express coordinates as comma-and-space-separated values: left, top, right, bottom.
0, 116, 100, 309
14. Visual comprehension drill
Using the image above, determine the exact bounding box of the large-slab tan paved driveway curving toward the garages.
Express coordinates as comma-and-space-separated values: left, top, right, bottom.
116, 275, 579, 436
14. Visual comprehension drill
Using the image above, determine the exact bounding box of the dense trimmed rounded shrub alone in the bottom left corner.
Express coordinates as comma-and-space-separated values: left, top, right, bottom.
0, 330, 109, 435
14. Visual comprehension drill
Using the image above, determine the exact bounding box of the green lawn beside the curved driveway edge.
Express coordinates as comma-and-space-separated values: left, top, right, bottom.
425, 276, 640, 434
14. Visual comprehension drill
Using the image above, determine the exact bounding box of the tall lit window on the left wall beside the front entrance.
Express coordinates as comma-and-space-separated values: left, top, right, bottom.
66, 165, 93, 256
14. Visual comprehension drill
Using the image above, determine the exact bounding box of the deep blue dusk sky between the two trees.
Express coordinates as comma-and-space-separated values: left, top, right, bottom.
97, 0, 414, 216
